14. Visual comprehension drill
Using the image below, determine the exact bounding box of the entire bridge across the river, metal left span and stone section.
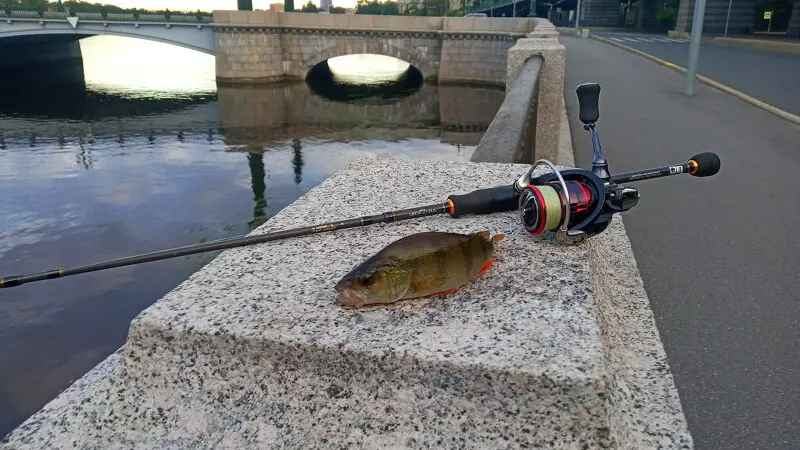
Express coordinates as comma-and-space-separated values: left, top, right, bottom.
0, 11, 537, 85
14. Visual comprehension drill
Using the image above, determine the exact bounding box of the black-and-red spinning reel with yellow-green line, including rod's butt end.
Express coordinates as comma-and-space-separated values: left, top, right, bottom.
514, 83, 720, 244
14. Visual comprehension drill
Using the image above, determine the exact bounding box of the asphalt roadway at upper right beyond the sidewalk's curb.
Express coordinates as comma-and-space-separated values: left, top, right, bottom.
594, 32, 800, 115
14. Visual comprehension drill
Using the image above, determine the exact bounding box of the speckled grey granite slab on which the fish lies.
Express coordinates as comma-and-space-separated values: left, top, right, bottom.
3, 156, 685, 449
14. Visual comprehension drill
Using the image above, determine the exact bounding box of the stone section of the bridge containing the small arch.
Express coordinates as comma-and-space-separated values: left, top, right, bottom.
212, 11, 536, 85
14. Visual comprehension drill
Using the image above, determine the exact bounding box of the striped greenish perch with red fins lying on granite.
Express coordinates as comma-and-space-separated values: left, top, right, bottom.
335, 231, 504, 307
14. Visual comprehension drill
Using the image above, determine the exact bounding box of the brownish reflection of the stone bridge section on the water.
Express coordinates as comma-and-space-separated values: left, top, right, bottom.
218, 79, 504, 147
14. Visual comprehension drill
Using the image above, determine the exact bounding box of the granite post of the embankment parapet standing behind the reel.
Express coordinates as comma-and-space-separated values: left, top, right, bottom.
506, 19, 567, 161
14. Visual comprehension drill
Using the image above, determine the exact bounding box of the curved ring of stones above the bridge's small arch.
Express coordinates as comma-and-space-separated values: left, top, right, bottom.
303, 40, 438, 79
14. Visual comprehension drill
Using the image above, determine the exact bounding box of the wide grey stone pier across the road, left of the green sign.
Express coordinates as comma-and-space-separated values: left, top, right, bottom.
675, 0, 756, 34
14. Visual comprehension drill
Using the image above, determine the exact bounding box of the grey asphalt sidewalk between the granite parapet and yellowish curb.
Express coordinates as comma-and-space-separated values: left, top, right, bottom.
561, 35, 800, 450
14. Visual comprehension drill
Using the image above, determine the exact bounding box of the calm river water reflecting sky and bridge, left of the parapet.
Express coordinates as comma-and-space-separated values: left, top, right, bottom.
0, 36, 504, 437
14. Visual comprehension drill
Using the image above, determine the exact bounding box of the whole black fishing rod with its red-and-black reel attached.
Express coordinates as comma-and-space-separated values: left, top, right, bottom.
0, 83, 720, 288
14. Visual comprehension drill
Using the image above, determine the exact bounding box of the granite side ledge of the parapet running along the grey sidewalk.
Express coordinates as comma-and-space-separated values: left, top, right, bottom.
558, 85, 694, 449
